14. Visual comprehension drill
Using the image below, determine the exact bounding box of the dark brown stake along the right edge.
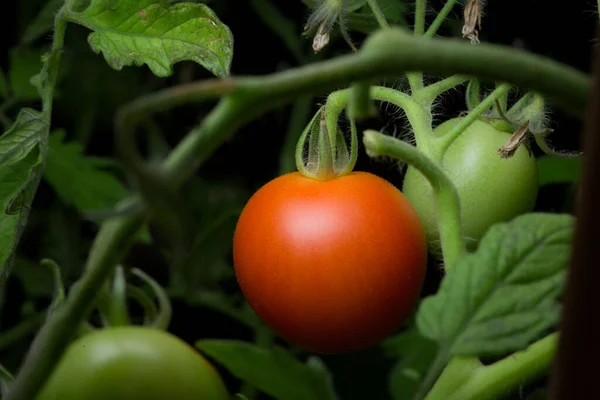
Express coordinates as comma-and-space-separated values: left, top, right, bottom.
549, 29, 600, 400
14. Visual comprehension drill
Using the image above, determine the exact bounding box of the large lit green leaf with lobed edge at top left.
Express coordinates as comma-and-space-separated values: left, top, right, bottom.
66, 0, 233, 77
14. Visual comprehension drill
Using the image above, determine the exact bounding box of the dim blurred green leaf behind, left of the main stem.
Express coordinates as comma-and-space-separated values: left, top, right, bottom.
44, 130, 150, 243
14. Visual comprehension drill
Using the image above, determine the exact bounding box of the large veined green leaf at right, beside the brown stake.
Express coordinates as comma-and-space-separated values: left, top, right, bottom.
417, 213, 574, 356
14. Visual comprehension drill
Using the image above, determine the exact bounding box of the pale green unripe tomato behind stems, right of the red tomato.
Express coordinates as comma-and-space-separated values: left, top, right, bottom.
402, 118, 538, 253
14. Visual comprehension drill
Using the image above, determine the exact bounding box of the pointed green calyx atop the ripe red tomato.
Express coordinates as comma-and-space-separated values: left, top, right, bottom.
296, 107, 358, 181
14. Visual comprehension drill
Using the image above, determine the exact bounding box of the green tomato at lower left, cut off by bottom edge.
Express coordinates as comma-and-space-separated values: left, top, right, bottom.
36, 326, 230, 400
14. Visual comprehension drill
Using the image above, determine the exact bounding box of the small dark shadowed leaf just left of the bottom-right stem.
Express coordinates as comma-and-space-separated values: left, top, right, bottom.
384, 329, 438, 400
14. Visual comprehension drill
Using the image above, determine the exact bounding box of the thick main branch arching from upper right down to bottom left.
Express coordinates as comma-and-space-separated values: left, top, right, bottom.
5, 28, 590, 400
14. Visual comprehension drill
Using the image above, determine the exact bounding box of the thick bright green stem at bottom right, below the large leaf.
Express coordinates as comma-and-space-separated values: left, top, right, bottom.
426, 332, 559, 400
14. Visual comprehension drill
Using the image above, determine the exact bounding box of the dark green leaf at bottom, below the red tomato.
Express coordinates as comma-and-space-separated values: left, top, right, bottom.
196, 340, 337, 400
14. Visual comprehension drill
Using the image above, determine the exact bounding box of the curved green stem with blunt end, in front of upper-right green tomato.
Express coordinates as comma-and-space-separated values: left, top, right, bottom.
363, 130, 466, 270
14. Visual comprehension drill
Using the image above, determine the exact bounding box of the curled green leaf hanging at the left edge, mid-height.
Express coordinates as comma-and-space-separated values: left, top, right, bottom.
0, 108, 48, 283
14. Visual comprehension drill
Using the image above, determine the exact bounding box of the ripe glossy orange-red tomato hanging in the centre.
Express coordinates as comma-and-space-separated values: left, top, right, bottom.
233, 172, 427, 353
